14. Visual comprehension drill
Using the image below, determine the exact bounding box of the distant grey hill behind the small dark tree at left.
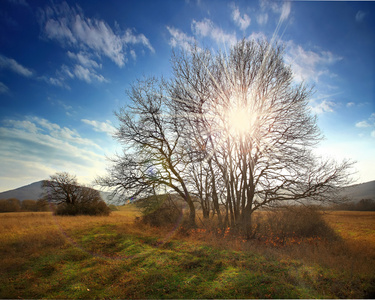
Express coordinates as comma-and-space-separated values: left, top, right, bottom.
0, 180, 116, 203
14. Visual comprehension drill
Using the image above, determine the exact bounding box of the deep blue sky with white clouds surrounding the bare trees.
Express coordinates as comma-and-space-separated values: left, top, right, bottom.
0, 0, 375, 192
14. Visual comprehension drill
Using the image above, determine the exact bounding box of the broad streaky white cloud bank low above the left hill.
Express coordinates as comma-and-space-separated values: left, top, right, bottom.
0, 117, 105, 190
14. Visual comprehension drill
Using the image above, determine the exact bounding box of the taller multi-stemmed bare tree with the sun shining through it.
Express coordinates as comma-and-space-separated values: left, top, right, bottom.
172, 40, 352, 237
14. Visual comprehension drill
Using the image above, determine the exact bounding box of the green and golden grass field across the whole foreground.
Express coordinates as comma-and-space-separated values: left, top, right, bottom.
0, 206, 375, 298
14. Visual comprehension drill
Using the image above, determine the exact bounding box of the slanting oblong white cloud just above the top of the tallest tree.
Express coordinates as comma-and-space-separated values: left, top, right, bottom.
191, 18, 237, 46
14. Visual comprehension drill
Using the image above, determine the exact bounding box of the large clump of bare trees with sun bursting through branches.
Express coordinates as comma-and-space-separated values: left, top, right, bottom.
98, 40, 352, 237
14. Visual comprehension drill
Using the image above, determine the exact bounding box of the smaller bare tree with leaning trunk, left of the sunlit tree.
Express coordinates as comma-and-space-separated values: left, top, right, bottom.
97, 78, 195, 226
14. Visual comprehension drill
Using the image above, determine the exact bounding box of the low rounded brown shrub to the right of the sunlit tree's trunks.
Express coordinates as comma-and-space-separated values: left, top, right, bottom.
259, 206, 335, 239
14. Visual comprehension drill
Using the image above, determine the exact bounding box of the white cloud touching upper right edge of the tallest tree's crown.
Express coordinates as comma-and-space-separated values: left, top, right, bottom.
284, 41, 342, 82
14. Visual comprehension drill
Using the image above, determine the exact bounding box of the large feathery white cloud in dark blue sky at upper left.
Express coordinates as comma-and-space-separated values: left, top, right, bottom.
39, 2, 155, 67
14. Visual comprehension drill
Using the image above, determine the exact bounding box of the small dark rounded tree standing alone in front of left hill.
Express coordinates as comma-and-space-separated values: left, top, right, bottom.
42, 172, 109, 215
